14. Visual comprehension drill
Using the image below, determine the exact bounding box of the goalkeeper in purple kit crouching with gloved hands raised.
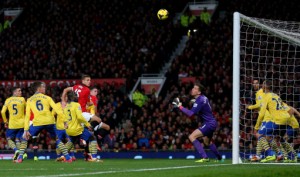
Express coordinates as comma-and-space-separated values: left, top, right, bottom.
172, 83, 221, 163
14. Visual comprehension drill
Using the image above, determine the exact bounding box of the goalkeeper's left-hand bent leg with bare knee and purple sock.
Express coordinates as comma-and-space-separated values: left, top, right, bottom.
189, 125, 209, 162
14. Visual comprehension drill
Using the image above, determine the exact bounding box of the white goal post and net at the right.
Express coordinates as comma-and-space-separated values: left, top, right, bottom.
233, 12, 300, 164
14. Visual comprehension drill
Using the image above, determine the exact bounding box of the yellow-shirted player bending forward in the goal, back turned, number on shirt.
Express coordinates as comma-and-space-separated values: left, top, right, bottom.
256, 80, 291, 162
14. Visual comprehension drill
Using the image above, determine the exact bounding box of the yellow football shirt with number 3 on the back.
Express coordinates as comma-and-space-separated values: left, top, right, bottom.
64, 102, 90, 136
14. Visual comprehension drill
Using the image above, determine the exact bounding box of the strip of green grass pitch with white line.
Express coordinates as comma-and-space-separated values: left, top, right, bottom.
0, 159, 300, 177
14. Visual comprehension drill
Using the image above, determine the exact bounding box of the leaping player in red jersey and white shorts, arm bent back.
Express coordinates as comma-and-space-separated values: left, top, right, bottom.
62, 75, 110, 131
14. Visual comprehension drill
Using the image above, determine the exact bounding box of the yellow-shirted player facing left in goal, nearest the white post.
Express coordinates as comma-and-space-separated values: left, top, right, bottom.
247, 79, 272, 162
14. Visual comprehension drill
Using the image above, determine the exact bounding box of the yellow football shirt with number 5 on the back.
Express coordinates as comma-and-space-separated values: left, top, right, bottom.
1, 96, 26, 129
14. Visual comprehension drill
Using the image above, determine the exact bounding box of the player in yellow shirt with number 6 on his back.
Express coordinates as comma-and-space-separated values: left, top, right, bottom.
22, 81, 72, 162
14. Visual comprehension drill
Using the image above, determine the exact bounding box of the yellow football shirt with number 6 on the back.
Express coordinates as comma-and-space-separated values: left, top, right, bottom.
24, 93, 65, 130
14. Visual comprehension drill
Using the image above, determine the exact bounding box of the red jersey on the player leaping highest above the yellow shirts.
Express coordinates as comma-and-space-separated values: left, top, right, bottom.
73, 84, 90, 112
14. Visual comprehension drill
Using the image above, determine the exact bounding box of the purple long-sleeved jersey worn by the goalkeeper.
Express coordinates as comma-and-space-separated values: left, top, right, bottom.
181, 95, 217, 127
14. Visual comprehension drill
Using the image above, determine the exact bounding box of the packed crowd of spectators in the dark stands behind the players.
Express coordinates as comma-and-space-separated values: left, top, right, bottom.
0, 0, 296, 155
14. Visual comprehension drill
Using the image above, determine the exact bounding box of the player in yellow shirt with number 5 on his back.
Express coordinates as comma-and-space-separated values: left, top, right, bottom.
1, 87, 27, 161
